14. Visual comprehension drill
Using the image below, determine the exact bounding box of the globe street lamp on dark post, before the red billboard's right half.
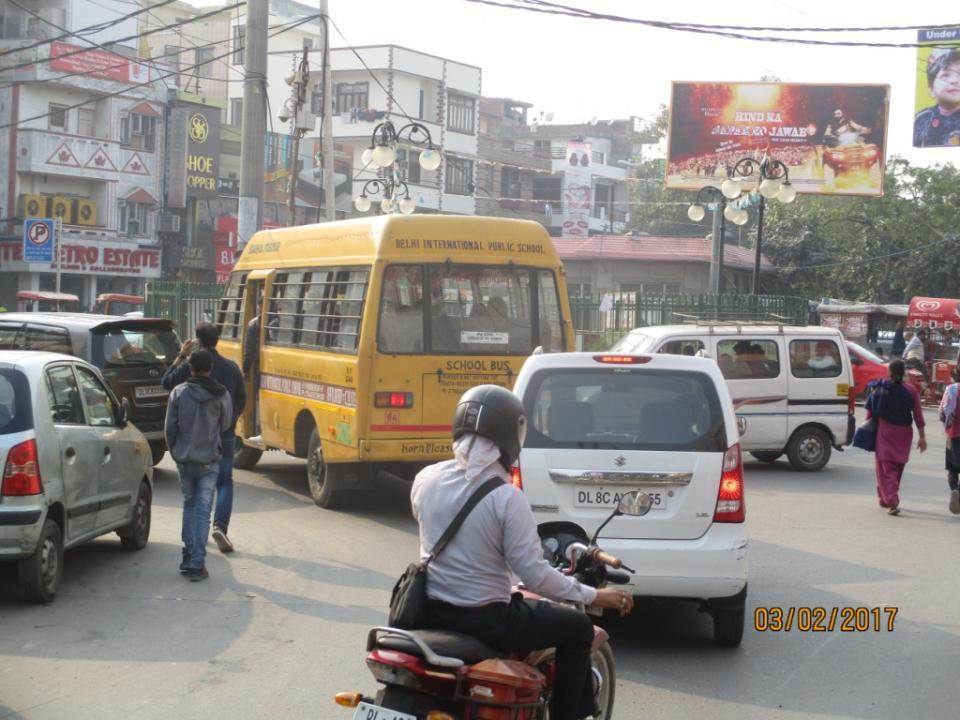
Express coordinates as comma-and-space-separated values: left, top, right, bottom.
720, 153, 797, 295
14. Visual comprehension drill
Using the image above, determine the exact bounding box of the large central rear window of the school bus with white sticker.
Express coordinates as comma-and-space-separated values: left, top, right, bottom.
429, 264, 533, 354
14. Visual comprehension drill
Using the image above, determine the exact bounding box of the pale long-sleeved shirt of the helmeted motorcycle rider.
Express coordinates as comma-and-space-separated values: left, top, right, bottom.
410, 436, 597, 607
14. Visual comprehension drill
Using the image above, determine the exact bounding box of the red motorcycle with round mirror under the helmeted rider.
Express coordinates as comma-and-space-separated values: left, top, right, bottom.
334, 491, 653, 720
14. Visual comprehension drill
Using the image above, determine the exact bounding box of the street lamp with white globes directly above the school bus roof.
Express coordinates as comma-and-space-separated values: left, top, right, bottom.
353, 120, 442, 215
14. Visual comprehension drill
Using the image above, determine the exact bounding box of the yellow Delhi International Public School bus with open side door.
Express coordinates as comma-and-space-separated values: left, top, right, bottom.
217, 215, 574, 507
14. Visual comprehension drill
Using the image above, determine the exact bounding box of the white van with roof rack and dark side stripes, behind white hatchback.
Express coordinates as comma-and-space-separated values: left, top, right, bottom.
610, 324, 856, 471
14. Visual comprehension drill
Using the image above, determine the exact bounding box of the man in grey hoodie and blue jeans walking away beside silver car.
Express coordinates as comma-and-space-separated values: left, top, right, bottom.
164, 350, 233, 582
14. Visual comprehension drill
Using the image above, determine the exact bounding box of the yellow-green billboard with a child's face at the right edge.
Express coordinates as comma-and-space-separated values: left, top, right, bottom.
913, 26, 960, 147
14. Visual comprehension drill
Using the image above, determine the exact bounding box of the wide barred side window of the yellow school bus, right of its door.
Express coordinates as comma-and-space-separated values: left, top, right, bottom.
266, 267, 370, 354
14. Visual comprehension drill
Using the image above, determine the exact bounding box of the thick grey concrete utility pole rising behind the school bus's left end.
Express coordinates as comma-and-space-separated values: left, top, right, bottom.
237, 0, 270, 250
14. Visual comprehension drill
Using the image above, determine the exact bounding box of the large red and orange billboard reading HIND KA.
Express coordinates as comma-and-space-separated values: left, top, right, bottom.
665, 82, 890, 195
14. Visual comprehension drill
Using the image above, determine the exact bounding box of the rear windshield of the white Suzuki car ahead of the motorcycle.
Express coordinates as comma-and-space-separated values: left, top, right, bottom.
524, 368, 726, 452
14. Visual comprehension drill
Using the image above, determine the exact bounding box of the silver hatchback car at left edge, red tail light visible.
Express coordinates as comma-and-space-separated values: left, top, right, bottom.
0, 351, 153, 603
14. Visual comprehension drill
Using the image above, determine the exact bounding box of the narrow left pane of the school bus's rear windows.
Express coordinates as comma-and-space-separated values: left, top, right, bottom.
377, 265, 423, 353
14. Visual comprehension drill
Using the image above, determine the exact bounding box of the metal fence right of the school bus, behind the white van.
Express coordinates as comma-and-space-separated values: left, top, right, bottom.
570, 293, 809, 350
